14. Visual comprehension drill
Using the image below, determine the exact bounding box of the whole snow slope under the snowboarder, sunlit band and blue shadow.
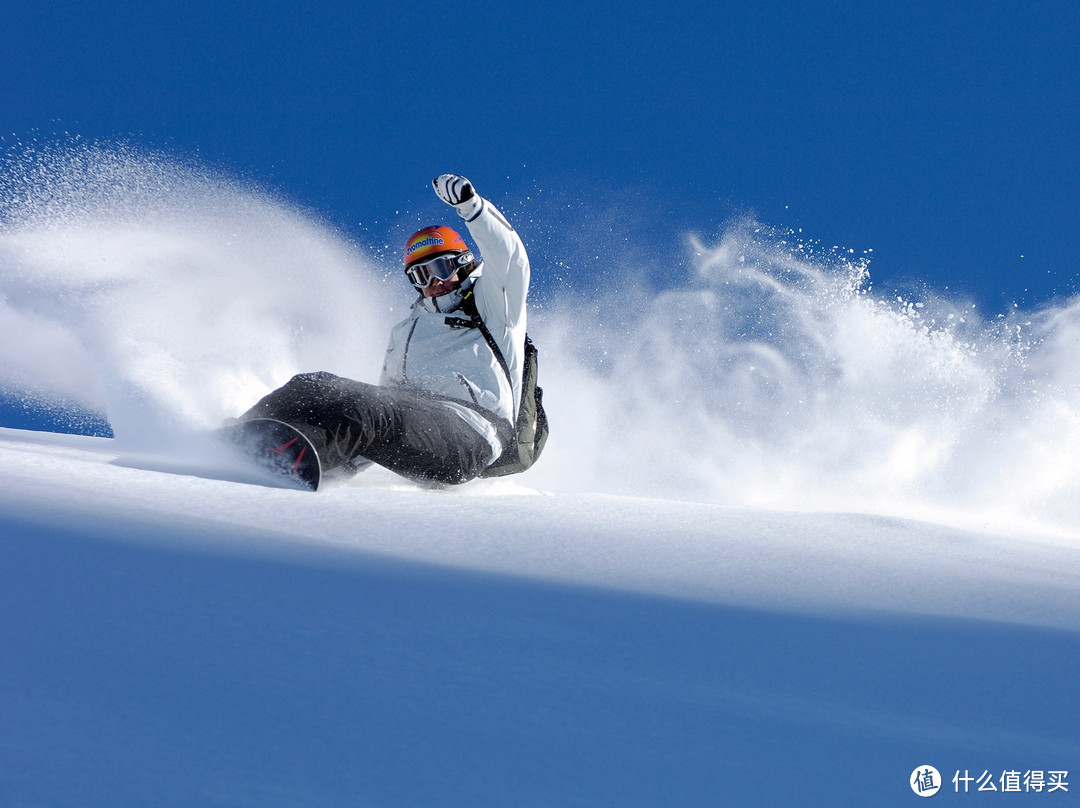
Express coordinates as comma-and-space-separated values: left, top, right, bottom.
0, 430, 1080, 806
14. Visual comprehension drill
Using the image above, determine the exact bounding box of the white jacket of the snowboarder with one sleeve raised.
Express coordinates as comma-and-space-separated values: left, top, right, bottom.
379, 198, 529, 458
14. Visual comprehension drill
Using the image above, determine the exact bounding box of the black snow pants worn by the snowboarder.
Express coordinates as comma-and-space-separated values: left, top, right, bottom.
241, 373, 492, 483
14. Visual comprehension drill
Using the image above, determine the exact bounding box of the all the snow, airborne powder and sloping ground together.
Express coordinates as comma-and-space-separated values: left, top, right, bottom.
6, 143, 1080, 807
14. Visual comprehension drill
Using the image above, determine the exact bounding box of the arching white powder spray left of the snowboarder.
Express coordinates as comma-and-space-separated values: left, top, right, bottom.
0, 139, 387, 444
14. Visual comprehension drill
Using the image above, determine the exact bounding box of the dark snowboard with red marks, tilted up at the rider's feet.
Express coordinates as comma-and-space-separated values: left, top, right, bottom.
221, 418, 323, 490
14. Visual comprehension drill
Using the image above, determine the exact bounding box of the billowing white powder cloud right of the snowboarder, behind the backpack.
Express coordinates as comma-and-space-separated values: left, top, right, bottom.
534, 221, 1080, 530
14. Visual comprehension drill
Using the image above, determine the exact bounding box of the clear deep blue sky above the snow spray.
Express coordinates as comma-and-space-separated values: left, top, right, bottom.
0, 0, 1080, 311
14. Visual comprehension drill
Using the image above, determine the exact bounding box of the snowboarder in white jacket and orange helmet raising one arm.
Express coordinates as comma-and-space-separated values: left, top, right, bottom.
227, 174, 529, 488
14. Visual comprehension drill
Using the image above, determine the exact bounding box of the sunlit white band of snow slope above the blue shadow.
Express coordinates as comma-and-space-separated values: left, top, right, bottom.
0, 429, 1080, 629
